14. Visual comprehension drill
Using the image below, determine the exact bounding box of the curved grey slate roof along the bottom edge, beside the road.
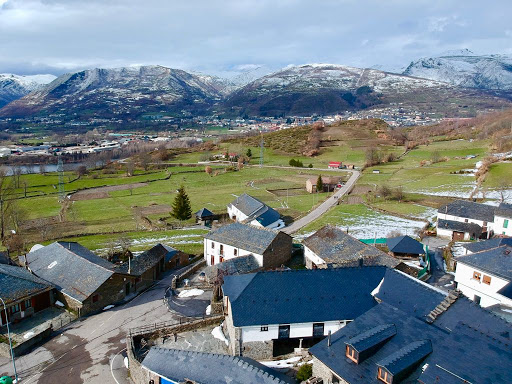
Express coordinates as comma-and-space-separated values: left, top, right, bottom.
142, 347, 296, 384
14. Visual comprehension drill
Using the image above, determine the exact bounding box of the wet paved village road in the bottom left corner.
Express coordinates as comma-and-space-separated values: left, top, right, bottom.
0, 274, 184, 384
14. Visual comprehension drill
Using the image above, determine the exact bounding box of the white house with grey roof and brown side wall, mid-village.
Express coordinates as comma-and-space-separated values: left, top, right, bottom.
204, 223, 292, 268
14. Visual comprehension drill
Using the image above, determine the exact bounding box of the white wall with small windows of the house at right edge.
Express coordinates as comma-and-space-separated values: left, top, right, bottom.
455, 261, 512, 307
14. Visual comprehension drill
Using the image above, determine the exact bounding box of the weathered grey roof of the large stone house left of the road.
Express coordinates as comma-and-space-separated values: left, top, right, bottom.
27, 241, 114, 302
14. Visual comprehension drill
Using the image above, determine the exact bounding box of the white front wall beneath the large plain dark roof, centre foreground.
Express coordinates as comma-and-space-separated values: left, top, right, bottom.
241, 320, 347, 343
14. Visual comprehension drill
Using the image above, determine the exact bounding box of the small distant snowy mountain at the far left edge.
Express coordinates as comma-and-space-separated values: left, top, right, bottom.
0, 73, 57, 108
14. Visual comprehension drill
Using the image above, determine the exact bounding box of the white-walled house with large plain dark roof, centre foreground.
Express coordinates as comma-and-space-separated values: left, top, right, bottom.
222, 267, 386, 359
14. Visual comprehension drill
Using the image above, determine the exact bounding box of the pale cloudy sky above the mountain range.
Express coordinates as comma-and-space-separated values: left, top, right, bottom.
0, 0, 512, 76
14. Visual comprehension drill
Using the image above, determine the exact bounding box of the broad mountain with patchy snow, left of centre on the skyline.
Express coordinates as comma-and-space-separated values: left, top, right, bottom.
0, 66, 223, 118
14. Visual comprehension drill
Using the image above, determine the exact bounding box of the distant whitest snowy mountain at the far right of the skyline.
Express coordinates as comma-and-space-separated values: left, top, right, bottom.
403, 49, 512, 91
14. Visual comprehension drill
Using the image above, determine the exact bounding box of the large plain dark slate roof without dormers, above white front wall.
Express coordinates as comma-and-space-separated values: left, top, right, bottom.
222, 266, 386, 327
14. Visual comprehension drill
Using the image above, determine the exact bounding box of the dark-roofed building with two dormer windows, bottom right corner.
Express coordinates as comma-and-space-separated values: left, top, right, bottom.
309, 270, 512, 384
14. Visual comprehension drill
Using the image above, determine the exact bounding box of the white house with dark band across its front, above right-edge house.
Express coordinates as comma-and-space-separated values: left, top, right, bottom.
437, 200, 496, 241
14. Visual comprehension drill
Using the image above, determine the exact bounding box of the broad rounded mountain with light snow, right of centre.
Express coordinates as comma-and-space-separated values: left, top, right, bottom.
221, 64, 500, 116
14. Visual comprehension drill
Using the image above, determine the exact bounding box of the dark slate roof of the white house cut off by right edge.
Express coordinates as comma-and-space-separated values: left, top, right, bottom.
457, 245, 512, 281
